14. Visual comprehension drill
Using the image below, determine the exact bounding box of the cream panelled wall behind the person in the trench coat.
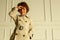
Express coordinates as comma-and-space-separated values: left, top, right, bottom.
0, 0, 60, 40
